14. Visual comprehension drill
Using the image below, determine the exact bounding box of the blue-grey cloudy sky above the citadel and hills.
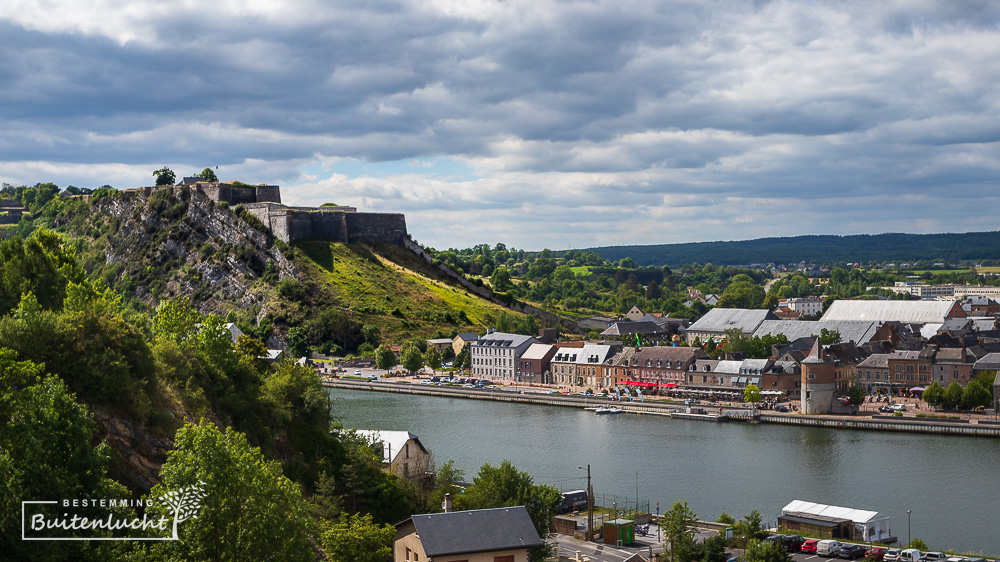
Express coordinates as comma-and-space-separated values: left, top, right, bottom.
0, 0, 1000, 249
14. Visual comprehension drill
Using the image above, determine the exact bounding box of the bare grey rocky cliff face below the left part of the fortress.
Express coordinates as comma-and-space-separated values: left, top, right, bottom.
56, 188, 298, 320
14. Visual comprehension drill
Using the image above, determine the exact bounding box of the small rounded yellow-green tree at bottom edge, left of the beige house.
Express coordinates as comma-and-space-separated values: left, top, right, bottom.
320, 513, 396, 562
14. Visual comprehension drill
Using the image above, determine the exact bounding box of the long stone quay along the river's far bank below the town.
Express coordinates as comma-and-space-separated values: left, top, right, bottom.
322, 379, 1000, 438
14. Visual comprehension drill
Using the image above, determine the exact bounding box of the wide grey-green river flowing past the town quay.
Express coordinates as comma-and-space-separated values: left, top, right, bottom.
329, 389, 1000, 555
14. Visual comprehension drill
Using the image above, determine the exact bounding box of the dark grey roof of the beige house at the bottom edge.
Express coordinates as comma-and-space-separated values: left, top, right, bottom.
397, 505, 544, 558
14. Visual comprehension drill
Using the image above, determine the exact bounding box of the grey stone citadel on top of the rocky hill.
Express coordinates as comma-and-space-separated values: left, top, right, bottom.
125, 177, 408, 246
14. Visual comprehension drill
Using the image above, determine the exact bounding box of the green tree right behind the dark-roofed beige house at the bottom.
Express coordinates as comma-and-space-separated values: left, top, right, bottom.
456, 460, 562, 562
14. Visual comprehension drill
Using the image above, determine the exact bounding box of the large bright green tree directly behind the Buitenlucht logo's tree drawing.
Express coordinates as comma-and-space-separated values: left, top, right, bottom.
151, 420, 315, 562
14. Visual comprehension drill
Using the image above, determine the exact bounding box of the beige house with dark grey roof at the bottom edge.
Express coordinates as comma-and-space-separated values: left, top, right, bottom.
392, 505, 545, 562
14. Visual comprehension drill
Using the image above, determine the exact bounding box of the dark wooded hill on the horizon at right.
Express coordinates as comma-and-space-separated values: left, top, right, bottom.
582, 231, 1000, 267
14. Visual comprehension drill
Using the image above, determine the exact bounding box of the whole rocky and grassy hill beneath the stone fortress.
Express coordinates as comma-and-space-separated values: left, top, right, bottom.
0, 184, 520, 355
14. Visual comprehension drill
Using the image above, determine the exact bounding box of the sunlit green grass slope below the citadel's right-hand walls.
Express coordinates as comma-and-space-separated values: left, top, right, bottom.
295, 240, 506, 339
